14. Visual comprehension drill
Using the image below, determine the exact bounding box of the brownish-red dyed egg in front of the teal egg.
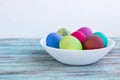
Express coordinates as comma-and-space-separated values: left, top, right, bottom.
83, 35, 104, 50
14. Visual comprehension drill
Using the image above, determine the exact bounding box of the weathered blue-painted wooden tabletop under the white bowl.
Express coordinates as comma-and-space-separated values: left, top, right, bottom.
0, 37, 120, 80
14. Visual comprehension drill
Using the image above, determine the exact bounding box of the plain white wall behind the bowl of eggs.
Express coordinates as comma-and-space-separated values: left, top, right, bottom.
0, 0, 120, 38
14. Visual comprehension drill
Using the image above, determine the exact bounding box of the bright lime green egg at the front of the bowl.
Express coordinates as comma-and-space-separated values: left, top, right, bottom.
59, 36, 83, 50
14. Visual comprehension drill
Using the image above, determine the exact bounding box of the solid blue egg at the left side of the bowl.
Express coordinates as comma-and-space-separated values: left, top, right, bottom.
46, 32, 62, 48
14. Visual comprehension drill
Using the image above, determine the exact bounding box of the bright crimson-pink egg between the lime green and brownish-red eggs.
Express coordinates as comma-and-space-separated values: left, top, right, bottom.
71, 31, 87, 43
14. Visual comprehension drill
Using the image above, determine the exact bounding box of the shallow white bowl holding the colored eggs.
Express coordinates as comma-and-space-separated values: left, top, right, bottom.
40, 38, 115, 65
